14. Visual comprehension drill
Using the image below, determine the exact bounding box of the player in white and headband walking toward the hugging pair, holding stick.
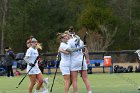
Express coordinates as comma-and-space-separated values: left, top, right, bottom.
24, 38, 48, 93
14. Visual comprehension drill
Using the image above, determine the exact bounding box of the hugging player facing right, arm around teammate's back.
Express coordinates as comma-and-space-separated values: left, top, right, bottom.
59, 34, 83, 93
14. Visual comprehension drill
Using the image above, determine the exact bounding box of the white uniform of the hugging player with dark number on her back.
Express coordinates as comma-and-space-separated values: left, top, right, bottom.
69, 38, 87, 71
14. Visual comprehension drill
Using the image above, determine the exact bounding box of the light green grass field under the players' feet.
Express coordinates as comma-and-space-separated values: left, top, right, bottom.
0, 73, 140, 93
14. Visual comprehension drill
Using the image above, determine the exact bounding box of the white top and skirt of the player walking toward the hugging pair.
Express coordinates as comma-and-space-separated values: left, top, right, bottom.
25, 47, 41, 74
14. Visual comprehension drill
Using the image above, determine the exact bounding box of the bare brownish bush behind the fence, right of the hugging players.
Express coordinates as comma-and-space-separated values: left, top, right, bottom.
79, 25, 118, 52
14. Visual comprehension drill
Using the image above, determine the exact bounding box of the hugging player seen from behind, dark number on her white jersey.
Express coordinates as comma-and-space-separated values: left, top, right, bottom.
69, 32, 92, 93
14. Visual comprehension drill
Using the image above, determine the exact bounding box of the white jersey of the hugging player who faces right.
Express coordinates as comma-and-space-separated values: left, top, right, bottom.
59, 42, 70, 67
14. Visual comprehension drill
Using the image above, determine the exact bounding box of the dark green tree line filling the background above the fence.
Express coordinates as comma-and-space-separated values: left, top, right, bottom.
0, 0, 140, 53
